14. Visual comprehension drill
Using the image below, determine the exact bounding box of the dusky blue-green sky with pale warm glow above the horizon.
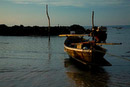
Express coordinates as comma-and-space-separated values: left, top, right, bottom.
0, 0, 130, 26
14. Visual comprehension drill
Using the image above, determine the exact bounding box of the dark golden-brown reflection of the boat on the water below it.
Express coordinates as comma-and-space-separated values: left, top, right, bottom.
64, 59, 110, 87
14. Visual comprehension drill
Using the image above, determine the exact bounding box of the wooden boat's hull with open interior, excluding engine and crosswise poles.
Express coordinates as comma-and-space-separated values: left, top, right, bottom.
64, 35, 109, 65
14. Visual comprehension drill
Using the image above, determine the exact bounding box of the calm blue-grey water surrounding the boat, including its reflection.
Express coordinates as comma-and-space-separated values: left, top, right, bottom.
0, 26, 130, 87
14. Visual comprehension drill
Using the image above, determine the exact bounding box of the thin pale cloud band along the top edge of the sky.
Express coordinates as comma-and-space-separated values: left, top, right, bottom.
10, 0, 130, 7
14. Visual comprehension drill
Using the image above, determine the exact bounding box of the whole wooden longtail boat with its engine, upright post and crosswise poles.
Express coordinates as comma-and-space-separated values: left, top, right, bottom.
59, 12, 121, 66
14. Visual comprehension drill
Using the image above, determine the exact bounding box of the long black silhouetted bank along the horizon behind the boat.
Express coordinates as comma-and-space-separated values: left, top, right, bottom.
0, 24, 90, 36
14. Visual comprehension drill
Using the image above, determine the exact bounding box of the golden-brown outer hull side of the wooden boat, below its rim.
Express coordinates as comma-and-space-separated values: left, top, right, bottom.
64, 45, 106, 65
